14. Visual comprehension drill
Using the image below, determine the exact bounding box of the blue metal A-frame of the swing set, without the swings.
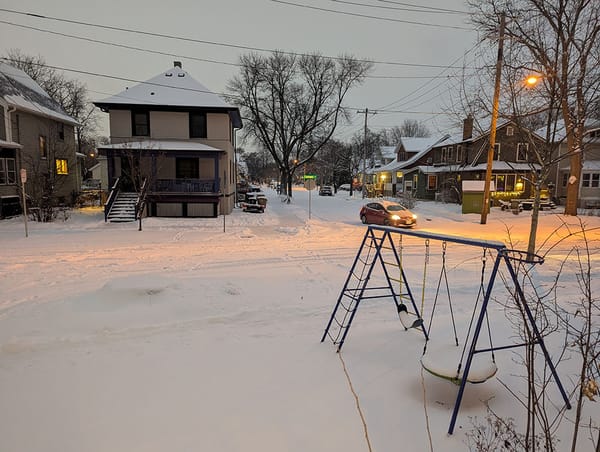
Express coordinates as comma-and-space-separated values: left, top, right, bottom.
321, 225, 571, 435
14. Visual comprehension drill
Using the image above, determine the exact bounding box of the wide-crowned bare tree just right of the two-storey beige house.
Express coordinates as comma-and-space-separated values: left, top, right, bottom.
228, 52, 372, 201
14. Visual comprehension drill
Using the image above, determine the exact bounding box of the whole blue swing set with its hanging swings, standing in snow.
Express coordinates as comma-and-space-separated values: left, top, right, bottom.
321, 225, 571, 434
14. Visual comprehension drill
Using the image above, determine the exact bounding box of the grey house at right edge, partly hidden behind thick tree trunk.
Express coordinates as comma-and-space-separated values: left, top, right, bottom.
555, 121, 600, 208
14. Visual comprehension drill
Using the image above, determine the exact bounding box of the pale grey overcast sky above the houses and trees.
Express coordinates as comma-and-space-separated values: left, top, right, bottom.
0, 0, 484, 140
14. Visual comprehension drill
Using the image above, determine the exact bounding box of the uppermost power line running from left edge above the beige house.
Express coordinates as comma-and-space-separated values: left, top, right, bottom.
0, 7, 474, 68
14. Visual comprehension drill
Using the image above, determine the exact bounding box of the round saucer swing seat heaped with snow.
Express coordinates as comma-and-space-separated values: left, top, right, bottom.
421, 344, 498, 384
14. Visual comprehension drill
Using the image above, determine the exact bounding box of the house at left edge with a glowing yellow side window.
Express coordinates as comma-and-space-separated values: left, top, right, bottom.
0, 62, 81, 218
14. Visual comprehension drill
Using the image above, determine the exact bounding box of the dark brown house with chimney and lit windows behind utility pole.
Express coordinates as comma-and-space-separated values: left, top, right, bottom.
380, 117, 544, 202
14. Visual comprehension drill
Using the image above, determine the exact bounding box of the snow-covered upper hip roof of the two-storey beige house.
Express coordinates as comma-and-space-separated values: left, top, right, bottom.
94, 62, 241, 127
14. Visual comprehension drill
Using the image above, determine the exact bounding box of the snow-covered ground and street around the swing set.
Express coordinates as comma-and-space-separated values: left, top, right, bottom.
0, 189, 600, 452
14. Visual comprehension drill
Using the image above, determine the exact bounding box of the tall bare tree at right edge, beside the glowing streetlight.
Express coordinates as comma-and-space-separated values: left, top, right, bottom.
469, 0, 600, 215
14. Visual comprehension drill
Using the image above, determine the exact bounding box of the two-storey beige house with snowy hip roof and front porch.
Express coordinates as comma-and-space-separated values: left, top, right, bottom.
95, 62, 242, 217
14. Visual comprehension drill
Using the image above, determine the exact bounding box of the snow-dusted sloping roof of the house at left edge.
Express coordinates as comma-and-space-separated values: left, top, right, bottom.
0, 62, 78, 125
